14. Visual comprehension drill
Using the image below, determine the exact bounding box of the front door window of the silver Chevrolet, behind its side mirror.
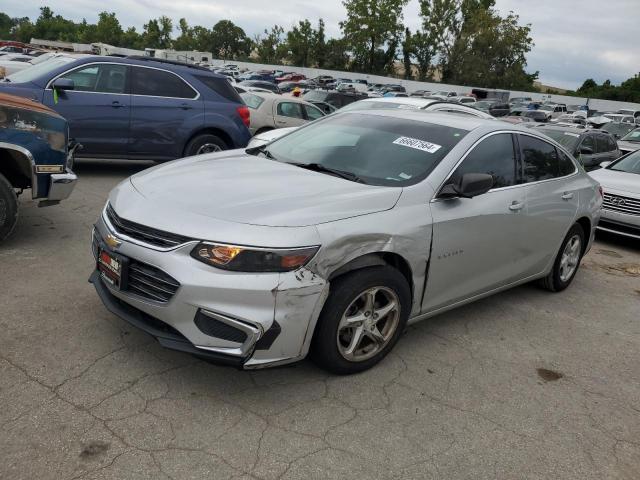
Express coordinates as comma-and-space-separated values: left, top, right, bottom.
451, 133, 516, 188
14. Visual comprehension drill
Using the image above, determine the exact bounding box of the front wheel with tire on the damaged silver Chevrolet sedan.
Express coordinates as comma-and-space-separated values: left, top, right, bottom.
311, 266, 411, 375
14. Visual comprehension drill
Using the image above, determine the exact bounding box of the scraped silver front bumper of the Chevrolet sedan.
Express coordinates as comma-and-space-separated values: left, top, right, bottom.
89, 216, 329, 369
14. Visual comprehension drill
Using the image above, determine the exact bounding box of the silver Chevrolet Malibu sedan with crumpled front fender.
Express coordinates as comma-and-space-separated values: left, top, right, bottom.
90, 110, 602, 374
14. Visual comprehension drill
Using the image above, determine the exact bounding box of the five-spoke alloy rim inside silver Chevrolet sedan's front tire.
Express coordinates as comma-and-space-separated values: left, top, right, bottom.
336, 287, 400, 362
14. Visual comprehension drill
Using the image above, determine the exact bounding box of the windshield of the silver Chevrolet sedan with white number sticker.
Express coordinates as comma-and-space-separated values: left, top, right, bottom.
258, 113, 468, 187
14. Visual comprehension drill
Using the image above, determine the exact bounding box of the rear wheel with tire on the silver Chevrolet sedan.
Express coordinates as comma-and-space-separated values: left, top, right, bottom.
540, 223, 585, 292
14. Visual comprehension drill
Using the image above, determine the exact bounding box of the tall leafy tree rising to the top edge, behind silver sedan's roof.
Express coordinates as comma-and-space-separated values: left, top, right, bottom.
340, 0, 408, 73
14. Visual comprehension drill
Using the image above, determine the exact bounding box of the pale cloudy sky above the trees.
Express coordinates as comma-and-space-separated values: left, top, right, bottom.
6, 0, 640, 88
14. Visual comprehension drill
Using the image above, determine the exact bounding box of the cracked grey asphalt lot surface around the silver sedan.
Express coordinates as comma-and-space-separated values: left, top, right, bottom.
0, 162, 640, 480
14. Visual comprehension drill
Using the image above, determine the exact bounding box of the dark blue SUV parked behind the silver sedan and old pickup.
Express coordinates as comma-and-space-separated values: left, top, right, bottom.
0, 55, 251, 160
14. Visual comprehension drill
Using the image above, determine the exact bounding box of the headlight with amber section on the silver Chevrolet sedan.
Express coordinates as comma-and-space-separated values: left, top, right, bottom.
191, 242, 319, 272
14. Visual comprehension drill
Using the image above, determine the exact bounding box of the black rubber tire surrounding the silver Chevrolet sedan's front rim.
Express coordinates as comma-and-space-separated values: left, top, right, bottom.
311, 266, 411, 375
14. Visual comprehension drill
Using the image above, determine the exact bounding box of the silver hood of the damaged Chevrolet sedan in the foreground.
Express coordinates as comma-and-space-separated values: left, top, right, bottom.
131, 150, 402, 227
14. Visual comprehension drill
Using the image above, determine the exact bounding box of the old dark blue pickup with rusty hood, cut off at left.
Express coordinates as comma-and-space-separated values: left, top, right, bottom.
0, 94, 78, 242
